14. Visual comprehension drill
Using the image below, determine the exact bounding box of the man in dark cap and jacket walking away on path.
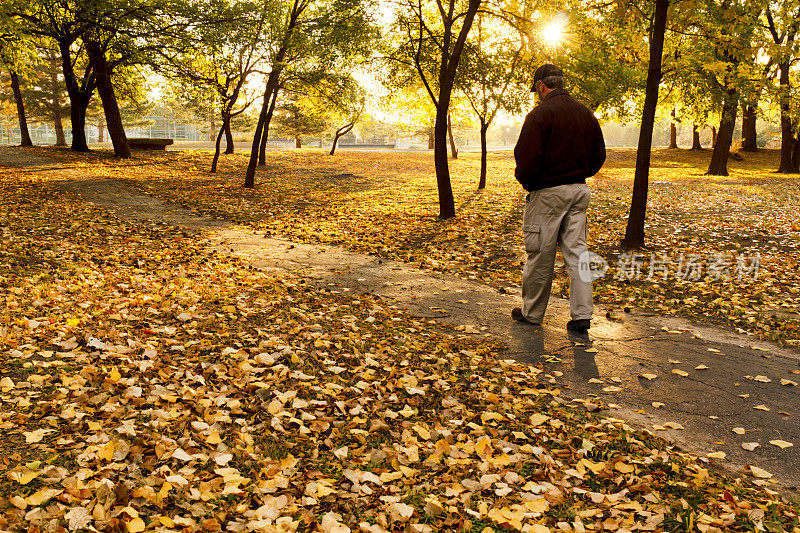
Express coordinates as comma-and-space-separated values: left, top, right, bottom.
511, 63, 606, 333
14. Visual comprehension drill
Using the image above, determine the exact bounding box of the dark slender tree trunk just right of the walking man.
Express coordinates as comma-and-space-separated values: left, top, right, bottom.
621, 0, 669, 248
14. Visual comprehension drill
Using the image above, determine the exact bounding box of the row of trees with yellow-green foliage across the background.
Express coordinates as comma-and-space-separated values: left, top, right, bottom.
0, 0, 800, 246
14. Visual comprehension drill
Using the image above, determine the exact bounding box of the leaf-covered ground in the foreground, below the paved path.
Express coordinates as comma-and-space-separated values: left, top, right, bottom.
0, 152, 800, 533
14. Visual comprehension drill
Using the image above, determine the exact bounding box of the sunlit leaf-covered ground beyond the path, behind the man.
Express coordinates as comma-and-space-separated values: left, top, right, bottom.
31, 145, 800, 346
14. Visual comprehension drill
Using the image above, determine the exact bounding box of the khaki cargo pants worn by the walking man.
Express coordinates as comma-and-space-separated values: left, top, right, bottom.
522, 183, 592, 323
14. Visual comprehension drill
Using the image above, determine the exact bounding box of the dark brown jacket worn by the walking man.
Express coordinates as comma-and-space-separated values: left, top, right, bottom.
514, 89, 606, 191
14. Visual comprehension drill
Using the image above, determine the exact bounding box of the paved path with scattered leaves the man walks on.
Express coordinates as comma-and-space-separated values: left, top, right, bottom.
0, 143, 800, 492
